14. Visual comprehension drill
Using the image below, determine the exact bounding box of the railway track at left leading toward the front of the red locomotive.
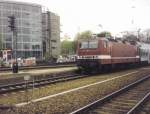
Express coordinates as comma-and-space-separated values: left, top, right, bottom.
0, 73, 88, 94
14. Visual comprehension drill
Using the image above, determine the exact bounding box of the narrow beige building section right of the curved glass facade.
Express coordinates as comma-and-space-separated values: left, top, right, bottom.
42, 11, 60, 59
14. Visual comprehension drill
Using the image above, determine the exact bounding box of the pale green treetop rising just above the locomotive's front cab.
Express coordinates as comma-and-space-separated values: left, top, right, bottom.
75, 30, 92, 40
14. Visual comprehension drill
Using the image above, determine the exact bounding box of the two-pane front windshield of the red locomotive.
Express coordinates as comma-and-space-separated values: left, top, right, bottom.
80, 41, 98, 49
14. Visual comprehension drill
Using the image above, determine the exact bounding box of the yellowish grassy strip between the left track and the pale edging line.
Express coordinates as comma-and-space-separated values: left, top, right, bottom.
0, 70, 138, 104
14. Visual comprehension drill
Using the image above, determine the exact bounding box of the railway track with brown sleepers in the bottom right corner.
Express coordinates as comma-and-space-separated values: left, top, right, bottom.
70, 75, 150, 114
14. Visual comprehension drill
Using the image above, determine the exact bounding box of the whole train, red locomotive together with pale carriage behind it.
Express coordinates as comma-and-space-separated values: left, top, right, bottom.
77, 37, 150, 71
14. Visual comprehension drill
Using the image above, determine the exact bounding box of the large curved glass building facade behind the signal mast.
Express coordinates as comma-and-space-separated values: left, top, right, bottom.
0, 1, 43, 59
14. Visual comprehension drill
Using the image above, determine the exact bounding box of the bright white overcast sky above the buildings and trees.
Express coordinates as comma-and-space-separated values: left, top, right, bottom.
9, 0, 150, 38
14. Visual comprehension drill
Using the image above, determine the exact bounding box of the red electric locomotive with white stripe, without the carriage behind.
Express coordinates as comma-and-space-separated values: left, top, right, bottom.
77, 37, 140, 71
